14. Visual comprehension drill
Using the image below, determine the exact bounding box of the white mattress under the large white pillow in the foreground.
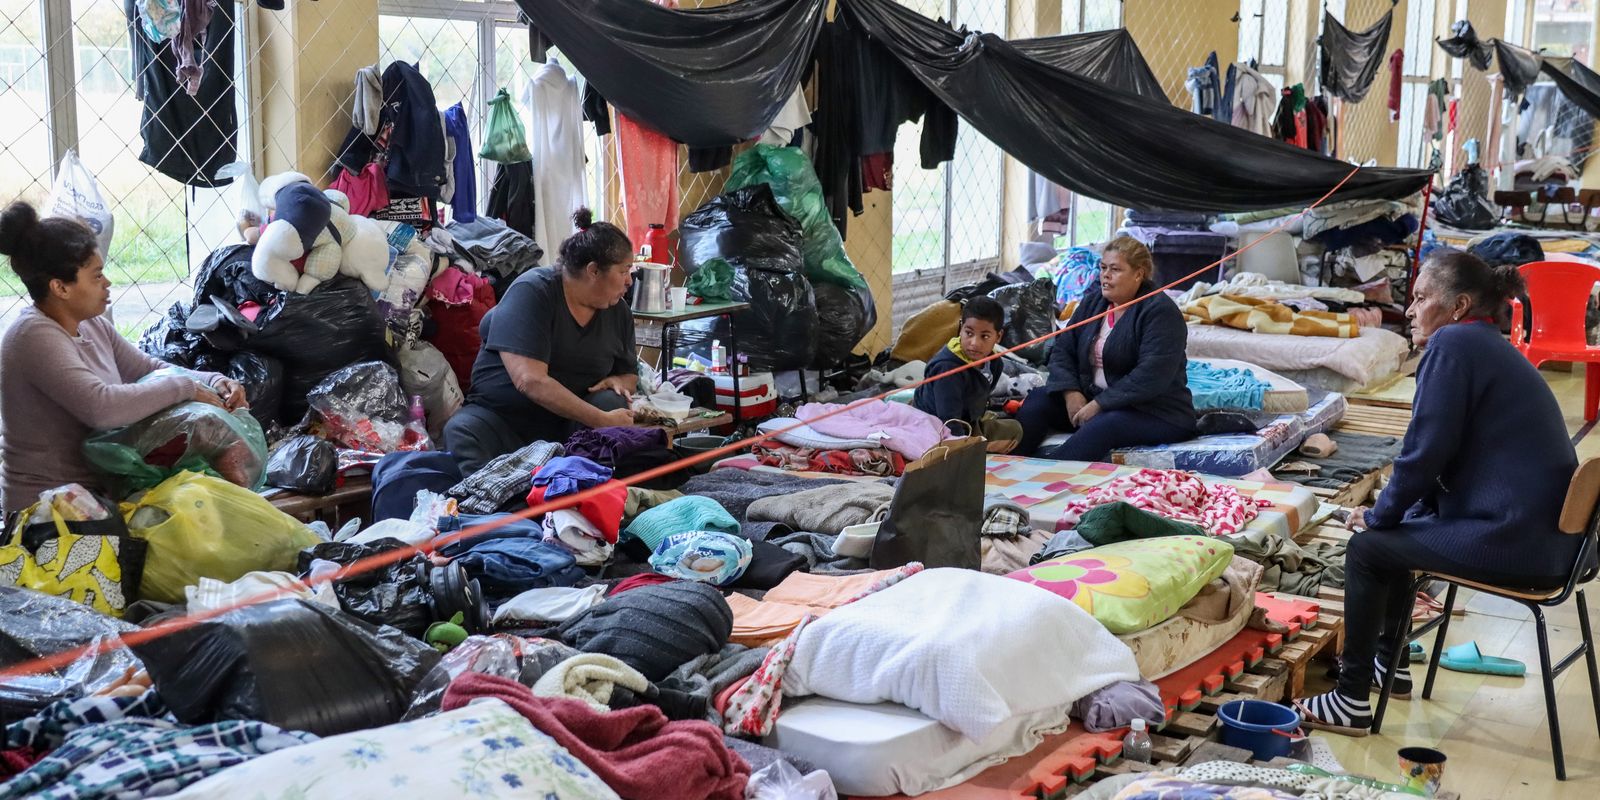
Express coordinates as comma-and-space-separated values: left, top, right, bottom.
762, 698, 1069, 797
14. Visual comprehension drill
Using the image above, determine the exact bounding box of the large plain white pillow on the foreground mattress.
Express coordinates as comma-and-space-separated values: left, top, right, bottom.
784, 570, 1139, 741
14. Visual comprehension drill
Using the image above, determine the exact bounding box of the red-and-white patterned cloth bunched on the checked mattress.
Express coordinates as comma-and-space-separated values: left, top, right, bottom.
1056, 469, 1272, 536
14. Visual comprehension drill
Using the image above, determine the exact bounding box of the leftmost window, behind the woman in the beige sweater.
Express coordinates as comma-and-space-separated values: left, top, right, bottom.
0, 0, 251, 338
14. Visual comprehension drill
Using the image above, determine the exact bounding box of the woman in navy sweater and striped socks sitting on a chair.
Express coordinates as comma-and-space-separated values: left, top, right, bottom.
1299, 251, 1579, 736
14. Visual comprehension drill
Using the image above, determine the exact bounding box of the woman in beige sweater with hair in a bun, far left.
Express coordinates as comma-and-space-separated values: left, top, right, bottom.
0, 202, 245, 515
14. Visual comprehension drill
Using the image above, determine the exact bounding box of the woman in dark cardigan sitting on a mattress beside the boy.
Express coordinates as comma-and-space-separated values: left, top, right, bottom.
1016, 237, 1195, 461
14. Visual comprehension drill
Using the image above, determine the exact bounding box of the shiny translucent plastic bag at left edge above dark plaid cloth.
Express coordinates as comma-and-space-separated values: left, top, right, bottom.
0, 586, 139, 722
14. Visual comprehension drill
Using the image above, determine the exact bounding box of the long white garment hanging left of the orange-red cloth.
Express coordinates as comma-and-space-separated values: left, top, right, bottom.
522, 61, 589, 253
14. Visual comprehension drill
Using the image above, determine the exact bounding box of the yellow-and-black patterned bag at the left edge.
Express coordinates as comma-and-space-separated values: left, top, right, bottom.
0, 489, 146, 616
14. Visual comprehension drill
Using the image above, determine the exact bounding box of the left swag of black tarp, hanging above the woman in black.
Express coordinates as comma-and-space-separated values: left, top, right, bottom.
517, 0, 827, 147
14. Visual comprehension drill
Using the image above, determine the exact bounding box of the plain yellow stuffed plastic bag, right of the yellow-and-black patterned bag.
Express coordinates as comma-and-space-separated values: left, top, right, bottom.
122, 472, 322, 603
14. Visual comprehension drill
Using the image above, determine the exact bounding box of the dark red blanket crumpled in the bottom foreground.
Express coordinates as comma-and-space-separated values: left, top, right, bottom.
443, 672, 750, 800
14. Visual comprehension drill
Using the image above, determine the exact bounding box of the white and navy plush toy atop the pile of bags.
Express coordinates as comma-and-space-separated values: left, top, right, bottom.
256, 173, 389, 294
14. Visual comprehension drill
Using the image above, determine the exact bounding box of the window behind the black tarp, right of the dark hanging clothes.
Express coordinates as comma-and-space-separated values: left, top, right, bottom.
893, 0, 1006, 272
